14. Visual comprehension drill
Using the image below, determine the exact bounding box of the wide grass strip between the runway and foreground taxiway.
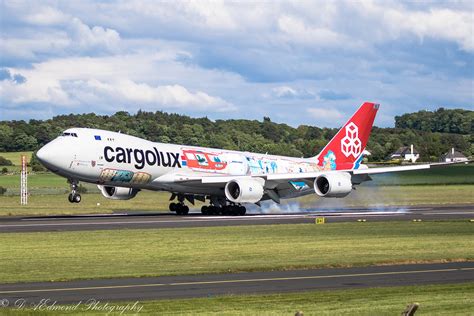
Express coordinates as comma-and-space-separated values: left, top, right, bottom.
0, 221, 474, 283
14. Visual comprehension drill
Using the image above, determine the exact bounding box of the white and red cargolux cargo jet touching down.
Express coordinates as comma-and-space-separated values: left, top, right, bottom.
37, 102, 462, 215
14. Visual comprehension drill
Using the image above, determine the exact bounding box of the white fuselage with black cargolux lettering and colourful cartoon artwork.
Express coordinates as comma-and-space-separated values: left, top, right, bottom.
38, 128, 329, 197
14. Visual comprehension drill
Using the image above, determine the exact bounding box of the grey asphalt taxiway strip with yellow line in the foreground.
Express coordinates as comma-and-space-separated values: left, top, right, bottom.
0, 262, 474, 304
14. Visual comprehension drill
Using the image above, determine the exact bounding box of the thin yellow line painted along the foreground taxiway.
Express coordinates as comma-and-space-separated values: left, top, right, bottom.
0, 267, 474, 294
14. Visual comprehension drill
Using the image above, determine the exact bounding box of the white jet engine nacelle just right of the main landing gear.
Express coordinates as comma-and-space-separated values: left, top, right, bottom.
225, 179, 263, 203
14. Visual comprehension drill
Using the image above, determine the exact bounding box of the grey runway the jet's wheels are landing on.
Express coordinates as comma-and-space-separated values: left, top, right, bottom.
0, 205, 474, 233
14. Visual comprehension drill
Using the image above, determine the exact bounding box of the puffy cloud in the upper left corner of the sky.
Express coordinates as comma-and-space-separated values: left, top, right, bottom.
0, 4, 121, 65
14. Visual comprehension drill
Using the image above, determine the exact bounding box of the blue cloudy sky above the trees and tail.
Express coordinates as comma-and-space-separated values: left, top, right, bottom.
0, 0, 474, 127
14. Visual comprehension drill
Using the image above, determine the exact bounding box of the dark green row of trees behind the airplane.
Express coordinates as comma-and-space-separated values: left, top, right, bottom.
0, 109, 474, 161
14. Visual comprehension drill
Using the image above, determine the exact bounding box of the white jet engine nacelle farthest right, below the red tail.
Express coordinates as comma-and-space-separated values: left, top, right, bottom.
314, 172, 352, 197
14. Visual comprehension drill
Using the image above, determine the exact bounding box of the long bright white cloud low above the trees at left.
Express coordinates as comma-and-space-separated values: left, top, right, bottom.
0, 53, 236, 112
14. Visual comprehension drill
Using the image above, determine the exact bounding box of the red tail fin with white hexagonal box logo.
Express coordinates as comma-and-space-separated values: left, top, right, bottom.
316, 102, 379, 170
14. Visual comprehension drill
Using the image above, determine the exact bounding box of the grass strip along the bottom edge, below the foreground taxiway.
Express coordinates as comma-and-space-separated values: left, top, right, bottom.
0, 283, 474, 315
